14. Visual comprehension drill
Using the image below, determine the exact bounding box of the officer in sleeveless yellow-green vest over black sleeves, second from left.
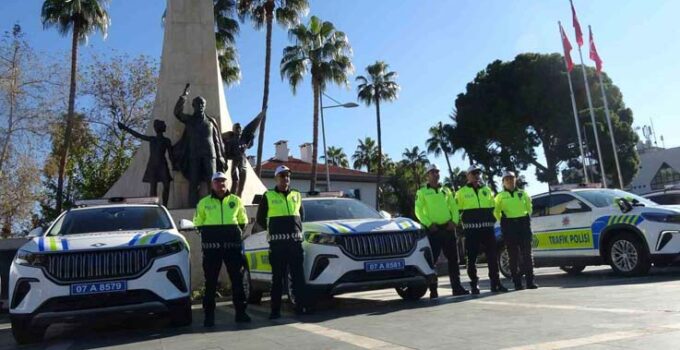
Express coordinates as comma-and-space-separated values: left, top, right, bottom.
257, 165, 309, 319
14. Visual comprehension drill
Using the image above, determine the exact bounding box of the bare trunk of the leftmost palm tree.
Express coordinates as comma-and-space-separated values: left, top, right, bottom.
56, 23, 79, 214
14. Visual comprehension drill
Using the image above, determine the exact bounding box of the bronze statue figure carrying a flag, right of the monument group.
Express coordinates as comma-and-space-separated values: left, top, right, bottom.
222, 111, 264, 197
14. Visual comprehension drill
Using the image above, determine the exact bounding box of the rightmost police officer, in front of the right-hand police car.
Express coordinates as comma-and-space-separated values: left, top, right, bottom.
494, 171, 538, 290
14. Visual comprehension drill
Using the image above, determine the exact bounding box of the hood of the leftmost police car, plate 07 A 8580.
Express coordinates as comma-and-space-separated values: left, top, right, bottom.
21, 230, 182, 252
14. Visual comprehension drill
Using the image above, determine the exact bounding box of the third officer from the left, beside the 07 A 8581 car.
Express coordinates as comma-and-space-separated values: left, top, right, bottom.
416, 164, 469, 299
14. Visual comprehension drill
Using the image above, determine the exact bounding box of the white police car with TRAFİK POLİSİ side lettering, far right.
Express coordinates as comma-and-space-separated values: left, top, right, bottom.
500, 188, 680, 277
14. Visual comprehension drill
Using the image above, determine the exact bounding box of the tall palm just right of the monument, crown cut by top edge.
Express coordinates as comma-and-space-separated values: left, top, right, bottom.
238, 0, 309, 176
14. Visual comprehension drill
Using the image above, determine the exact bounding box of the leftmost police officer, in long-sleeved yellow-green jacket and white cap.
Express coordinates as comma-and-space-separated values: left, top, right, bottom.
194, 172, 250, 327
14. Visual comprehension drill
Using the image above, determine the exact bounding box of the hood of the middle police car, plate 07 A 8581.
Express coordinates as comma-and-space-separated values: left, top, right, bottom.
302, 218, 420, 234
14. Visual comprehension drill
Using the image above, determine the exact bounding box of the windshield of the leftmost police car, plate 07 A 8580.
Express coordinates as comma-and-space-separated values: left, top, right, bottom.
47, 206, 172, 236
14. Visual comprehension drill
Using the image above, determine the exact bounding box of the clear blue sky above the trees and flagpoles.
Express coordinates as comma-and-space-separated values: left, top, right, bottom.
0, 0, 680, 193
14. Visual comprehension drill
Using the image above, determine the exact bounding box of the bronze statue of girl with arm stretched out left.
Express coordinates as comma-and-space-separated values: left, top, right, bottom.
118, 119, 172, 206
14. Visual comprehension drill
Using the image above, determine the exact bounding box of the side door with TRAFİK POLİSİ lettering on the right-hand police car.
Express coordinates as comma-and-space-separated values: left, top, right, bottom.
532, 193, 599, 258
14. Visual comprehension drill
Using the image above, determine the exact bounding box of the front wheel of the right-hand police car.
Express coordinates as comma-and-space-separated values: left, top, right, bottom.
607, 232, 651, 276
